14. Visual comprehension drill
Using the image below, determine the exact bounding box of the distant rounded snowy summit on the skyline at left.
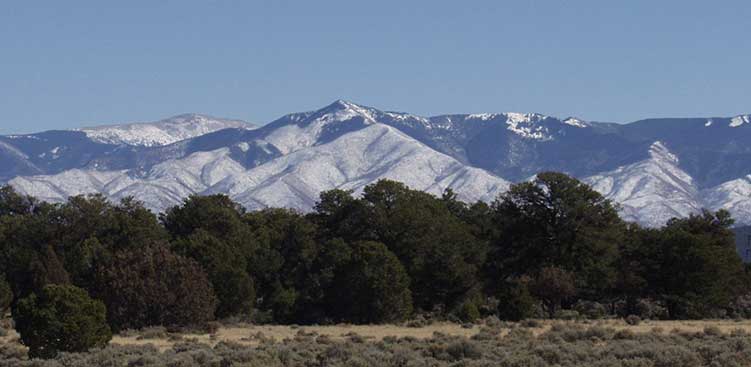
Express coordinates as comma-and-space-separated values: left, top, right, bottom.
79, 114, 255, 147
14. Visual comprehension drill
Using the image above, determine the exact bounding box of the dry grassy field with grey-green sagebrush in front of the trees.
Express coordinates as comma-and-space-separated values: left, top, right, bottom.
0, 320, 751, 367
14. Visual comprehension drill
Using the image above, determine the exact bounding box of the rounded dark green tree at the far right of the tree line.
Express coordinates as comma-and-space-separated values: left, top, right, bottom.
631, 210, 745, 318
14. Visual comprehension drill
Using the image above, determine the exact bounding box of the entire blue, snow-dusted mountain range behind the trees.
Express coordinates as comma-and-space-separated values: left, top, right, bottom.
0, 100, 751, 230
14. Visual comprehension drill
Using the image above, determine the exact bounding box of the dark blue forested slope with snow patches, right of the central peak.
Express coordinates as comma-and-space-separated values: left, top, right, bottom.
381, 113, 646, 181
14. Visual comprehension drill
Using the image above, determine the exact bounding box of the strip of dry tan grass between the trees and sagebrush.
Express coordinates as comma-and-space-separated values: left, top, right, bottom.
0, 319, 751, 350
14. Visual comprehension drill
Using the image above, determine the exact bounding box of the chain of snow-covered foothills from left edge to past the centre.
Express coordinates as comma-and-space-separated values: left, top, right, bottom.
10, 124, 509, 211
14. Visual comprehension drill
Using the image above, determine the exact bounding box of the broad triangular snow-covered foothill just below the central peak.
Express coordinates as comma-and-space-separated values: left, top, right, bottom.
222, 124, 509, 209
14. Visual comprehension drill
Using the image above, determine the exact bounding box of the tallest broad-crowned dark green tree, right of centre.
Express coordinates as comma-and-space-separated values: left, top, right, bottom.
488, 172, 625, 296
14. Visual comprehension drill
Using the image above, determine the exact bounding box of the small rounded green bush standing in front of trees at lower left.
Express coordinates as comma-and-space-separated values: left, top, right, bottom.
13, 285, 112, 358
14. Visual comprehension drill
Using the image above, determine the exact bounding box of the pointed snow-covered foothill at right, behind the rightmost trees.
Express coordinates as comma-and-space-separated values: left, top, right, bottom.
584, 141, 702, 227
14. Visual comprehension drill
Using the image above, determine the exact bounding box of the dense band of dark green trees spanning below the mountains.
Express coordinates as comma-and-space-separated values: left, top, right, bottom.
0, 172, 751, 356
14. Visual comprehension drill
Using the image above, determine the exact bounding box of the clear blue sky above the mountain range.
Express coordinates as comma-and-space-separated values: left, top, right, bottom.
0, 0, 751, 134
